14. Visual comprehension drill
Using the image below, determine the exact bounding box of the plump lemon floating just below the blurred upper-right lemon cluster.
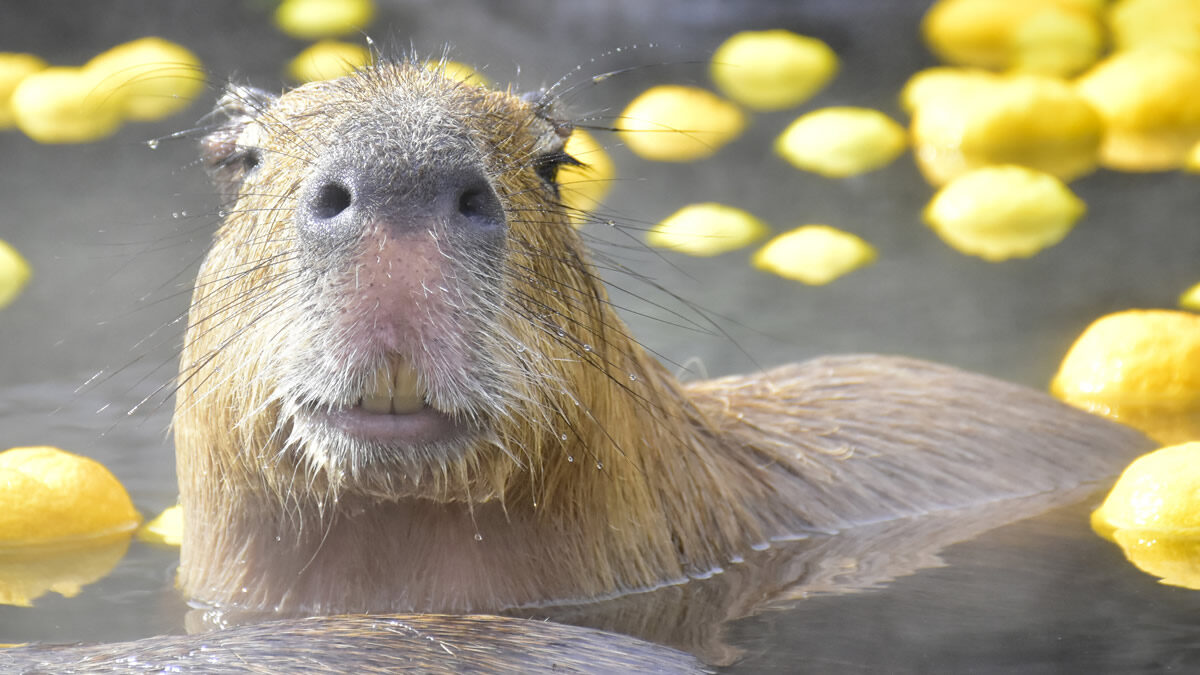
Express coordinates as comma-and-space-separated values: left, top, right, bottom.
924, 166, 1087, 262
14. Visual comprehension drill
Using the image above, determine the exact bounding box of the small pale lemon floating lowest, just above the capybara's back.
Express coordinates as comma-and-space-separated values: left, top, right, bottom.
754, 225, 876, 286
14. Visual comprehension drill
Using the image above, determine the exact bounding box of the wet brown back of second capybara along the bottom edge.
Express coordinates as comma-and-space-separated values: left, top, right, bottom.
0, 615, 704, 675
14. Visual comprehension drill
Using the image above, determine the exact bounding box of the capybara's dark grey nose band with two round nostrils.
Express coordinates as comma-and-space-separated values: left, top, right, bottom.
295, 167, 505, 249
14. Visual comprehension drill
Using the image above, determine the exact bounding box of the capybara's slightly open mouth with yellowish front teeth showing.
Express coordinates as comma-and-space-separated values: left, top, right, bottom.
297, 357, 478, 447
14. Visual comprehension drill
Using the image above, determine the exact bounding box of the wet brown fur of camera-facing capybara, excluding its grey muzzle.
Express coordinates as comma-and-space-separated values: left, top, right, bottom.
175, 64, 1146, 614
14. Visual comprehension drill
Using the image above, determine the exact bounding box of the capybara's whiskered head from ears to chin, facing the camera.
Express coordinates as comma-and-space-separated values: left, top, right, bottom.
175, 62, 644, 501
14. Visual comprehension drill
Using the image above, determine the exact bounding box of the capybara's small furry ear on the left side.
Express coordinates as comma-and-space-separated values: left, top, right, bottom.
200, 84, 278, 202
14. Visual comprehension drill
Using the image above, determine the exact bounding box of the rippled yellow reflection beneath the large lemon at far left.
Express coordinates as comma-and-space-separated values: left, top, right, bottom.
0, 530, 130, 607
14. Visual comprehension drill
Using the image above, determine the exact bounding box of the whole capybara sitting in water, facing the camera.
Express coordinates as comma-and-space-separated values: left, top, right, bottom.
174, 62, 1146, 614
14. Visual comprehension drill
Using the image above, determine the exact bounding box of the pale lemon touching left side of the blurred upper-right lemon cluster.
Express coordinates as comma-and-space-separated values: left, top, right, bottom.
775, 107, 908, 178
